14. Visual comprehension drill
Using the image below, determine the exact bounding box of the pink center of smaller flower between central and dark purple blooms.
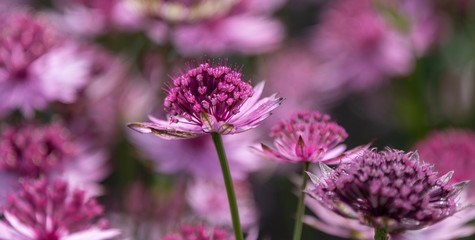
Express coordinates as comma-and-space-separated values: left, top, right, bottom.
271, 112, 348, 160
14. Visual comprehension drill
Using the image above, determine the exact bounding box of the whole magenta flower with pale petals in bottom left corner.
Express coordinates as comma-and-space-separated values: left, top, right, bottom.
0, 178, 120, 240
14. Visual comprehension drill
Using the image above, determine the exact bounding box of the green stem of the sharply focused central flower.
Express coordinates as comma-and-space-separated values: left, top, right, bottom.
211, 133, 244, 240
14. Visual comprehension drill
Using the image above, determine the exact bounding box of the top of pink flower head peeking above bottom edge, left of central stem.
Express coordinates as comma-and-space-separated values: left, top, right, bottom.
164, 224, 234, 240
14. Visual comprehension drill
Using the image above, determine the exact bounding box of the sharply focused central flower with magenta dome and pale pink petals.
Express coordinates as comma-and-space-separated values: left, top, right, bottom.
129, 63, 282, 139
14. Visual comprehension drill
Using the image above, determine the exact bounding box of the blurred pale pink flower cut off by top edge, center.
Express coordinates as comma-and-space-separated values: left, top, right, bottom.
123, 0, 285, 56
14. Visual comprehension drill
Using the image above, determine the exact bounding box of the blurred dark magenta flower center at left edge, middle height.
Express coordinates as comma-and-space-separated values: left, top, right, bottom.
0, 124, 76, 177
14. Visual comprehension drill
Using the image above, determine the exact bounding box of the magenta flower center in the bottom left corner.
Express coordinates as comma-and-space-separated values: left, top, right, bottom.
5, 179, 106, 236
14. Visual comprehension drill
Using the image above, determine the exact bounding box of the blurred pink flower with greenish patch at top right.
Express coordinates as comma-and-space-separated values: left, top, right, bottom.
314, 0, 437, 90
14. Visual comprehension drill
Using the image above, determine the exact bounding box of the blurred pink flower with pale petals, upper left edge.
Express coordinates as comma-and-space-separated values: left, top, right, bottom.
0, 11, 90, 116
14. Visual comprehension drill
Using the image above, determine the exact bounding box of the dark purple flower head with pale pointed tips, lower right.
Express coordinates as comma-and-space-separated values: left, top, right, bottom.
308, 148, 467, 233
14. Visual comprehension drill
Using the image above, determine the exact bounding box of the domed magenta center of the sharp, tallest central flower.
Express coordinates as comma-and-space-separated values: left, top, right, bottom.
164, 63, 254, 125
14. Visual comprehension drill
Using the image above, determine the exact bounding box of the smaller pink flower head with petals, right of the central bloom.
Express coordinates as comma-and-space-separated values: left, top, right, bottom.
257, 112, 348, 162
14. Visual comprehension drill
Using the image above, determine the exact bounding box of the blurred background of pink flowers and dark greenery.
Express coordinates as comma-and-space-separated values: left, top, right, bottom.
0, 0, 475, 240
